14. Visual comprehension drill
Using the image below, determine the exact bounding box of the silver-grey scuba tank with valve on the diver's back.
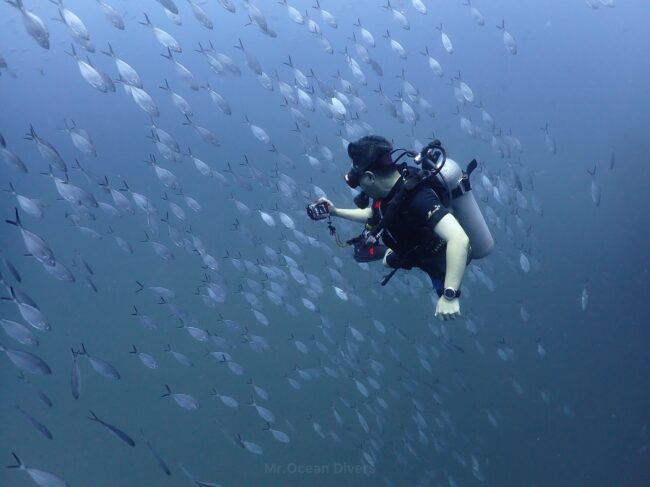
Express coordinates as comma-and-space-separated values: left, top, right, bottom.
415, 140, 494, 259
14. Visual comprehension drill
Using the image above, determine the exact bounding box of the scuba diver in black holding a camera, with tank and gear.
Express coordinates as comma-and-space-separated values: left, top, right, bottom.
307, 135, 494, 321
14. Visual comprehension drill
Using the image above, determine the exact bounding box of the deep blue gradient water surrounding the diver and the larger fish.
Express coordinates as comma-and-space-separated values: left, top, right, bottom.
0, 0, 650, 487
